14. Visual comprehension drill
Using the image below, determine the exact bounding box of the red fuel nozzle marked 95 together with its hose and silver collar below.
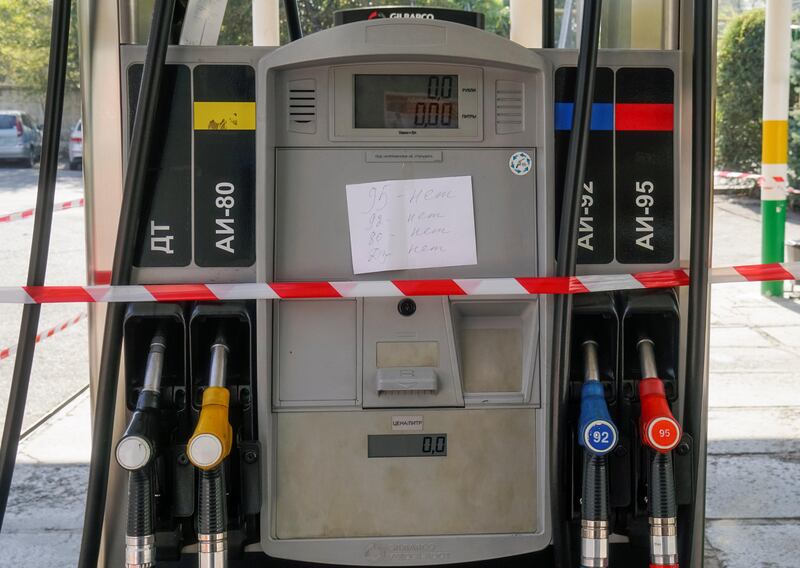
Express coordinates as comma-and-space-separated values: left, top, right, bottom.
637, 338, 681, 568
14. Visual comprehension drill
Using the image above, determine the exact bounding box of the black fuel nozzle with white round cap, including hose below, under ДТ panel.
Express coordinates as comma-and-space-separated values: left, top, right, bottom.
116, 334, 166, 568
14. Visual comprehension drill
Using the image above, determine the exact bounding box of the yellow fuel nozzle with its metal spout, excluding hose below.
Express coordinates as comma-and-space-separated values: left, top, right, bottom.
186, 343, 233, 470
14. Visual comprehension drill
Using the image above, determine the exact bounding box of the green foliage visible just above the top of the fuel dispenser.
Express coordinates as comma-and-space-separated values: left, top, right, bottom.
219, 0, 510, 45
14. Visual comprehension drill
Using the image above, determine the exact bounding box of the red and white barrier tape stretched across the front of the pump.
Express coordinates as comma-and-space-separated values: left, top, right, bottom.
0, 262, 800, 304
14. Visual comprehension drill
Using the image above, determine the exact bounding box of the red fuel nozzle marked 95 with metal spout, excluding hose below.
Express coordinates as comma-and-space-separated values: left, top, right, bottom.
637, 339, 681, 453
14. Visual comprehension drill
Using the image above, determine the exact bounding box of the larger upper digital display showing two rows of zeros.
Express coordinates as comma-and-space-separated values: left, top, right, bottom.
353, 75, 458, 129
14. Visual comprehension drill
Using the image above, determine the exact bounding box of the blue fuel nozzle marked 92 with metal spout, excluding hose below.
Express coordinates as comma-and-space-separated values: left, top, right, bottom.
578, 341, 619, 456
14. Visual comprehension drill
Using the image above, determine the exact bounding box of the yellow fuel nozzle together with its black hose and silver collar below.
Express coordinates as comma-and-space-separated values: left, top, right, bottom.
186, 339, 233, 568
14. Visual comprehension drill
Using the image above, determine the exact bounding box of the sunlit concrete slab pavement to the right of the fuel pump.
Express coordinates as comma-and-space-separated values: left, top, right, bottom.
706, 194, 800, 568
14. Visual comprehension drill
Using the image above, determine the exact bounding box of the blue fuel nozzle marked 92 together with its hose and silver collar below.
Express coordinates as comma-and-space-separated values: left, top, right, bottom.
578, 341, 619, 568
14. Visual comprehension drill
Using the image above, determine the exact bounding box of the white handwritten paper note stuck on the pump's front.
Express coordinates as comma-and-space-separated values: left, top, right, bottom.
347, 176, 478, 274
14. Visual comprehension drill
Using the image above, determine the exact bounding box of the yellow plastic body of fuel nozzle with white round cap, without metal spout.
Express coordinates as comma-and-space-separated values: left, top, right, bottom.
186, 387, 233, 470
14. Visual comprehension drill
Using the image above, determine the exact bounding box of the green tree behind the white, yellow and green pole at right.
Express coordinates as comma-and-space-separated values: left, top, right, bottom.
716, 10, 800, 184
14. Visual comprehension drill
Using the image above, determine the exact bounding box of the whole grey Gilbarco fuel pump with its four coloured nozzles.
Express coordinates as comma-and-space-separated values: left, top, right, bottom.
70, 0, 713, 568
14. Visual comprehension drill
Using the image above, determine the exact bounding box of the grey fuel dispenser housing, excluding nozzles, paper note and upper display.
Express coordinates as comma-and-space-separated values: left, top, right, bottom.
81, 11, 716, 566
